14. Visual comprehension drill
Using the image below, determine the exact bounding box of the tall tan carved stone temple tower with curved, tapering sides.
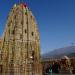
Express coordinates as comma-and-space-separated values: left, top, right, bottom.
2, 4, 42, 75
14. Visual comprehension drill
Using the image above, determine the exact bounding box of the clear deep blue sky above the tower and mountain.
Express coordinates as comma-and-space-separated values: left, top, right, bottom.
0, 0, 75, 54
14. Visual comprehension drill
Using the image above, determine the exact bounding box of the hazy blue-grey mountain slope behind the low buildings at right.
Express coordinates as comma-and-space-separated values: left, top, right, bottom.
42, 46, 75, 59
